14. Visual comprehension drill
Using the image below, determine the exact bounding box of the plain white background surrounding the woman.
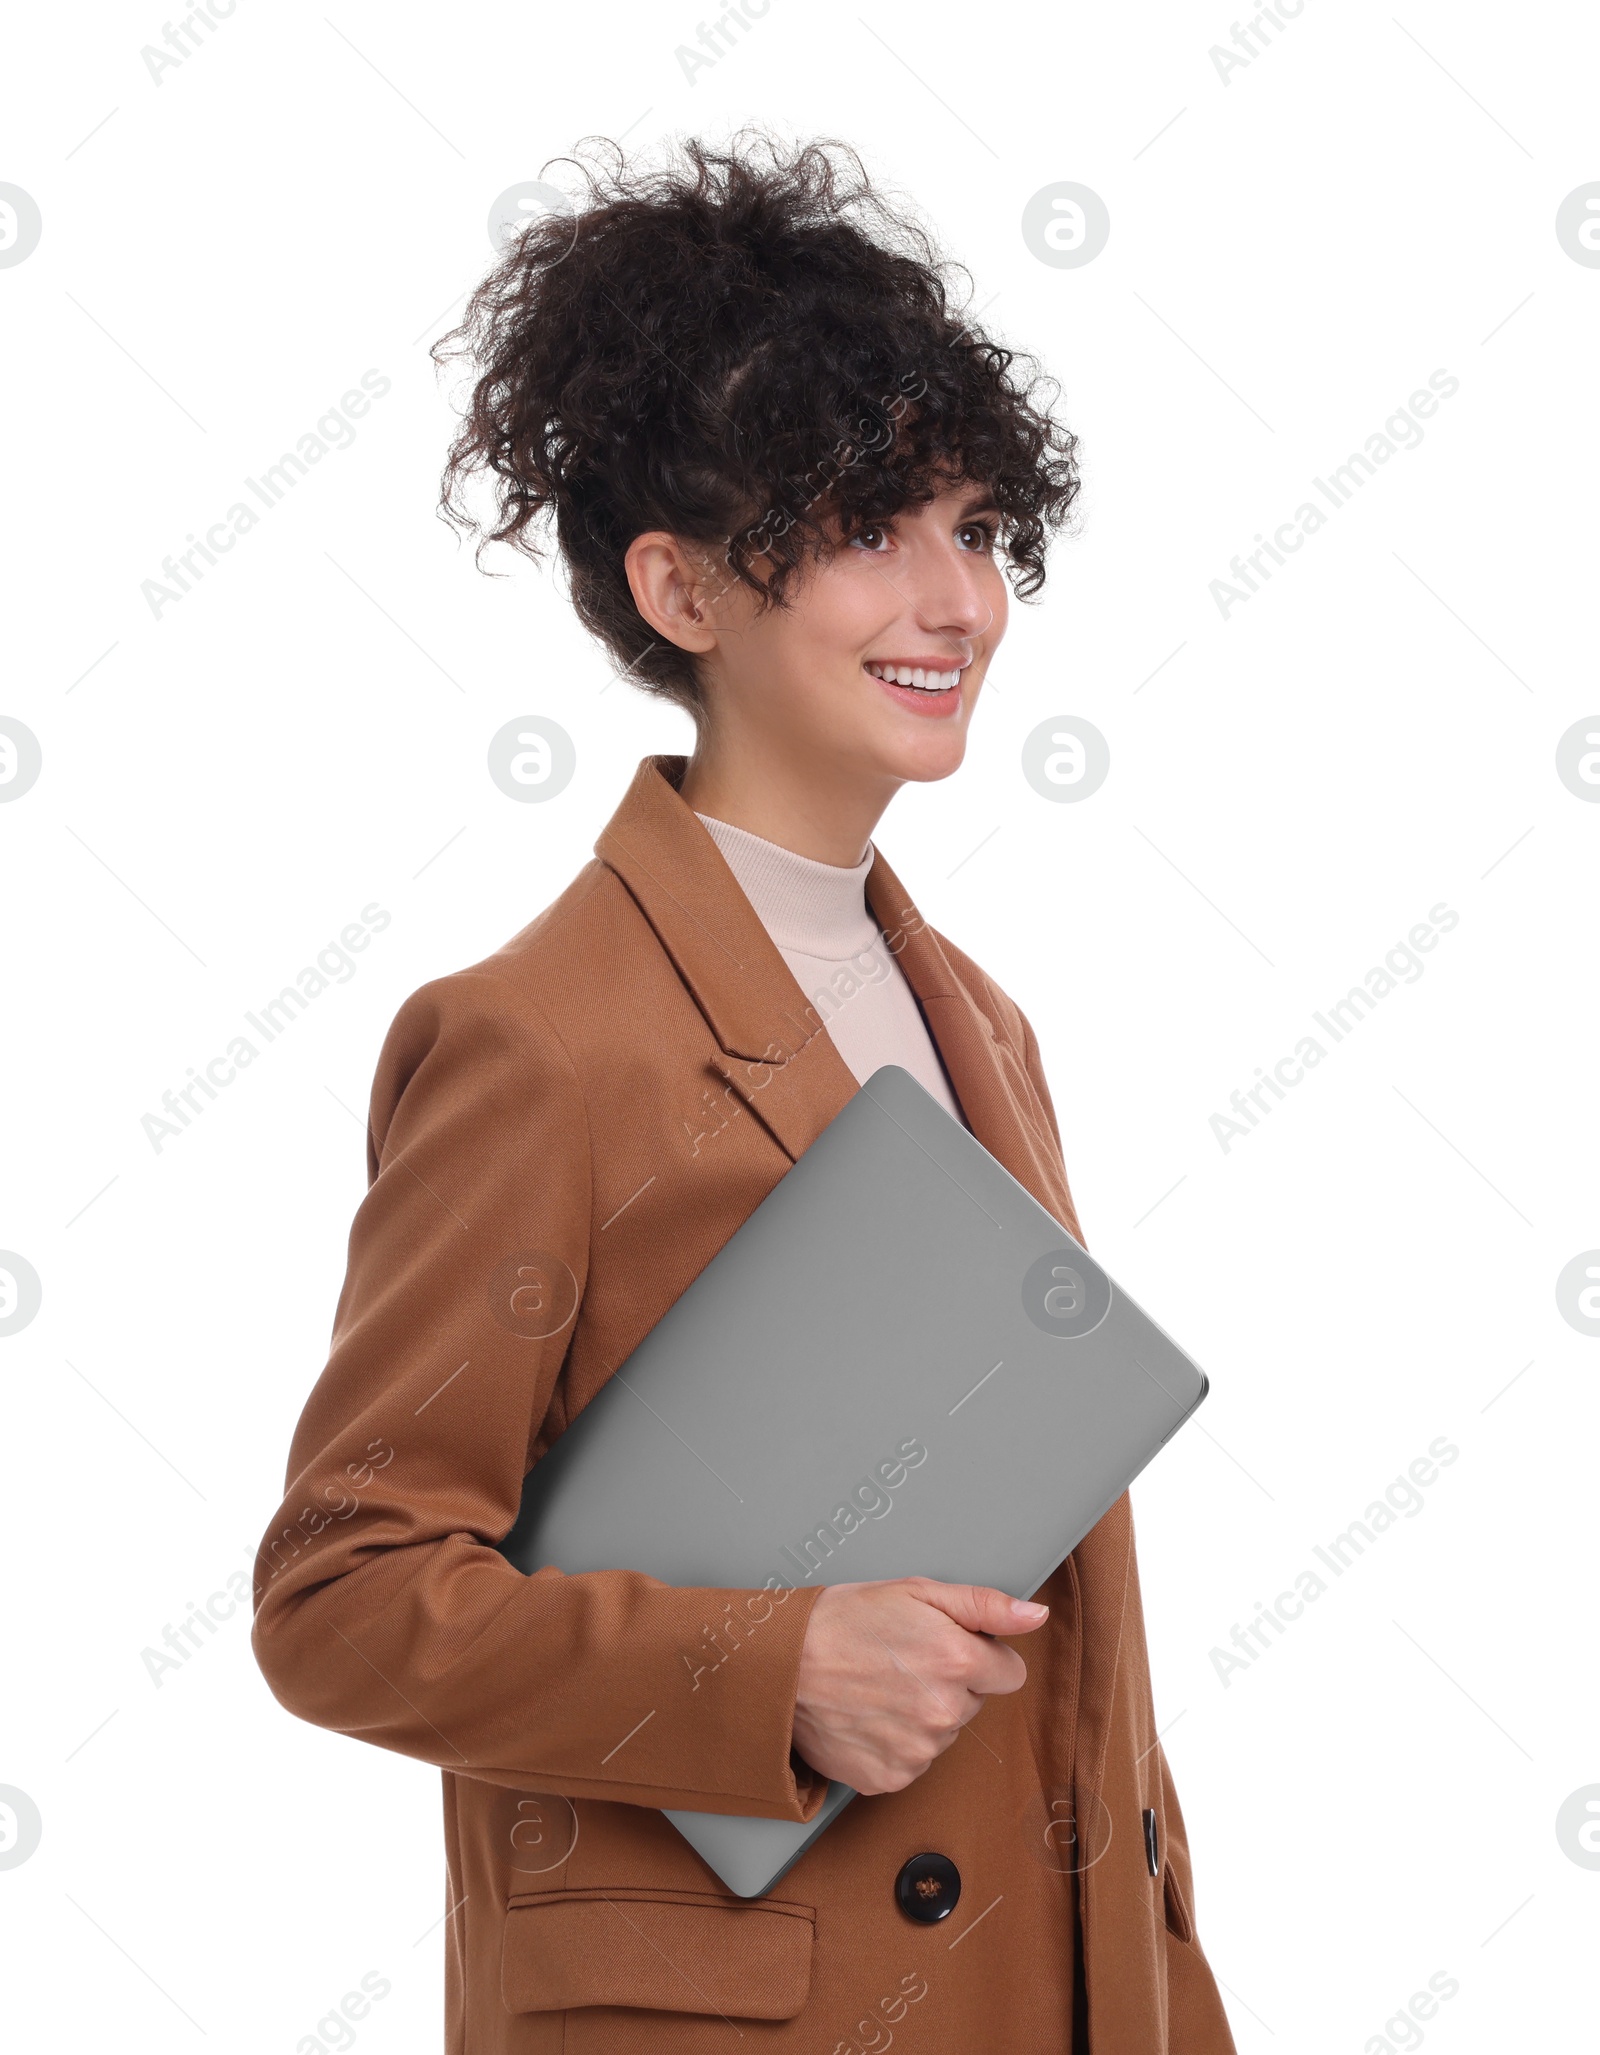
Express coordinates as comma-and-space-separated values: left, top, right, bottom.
0, 0, 1600, 2055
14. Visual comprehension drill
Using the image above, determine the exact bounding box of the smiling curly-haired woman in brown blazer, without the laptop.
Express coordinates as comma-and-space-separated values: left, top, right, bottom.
255, 138, 1232, 2055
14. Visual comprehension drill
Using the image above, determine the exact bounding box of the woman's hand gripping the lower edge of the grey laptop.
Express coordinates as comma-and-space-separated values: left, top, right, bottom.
793, 1576, 1050, 1794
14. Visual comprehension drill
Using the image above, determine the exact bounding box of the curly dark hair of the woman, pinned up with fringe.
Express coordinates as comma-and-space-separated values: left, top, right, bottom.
433, 129, 1078, 717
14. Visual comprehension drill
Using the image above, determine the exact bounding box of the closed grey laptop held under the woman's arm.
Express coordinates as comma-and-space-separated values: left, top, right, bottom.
501, 1064, 1208, 1897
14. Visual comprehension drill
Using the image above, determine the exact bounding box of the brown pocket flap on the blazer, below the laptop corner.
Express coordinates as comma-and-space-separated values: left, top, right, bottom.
501, 1889, 815, 2020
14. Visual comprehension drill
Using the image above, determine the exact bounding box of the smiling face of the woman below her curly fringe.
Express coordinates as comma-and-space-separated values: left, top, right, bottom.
700, 485, 1008, 785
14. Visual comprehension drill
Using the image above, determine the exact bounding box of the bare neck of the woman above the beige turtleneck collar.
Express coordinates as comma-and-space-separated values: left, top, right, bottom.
680, 727, 902, 867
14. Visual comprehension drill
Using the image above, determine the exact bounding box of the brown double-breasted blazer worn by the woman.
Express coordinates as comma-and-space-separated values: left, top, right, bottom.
255, 756, 1232, 2055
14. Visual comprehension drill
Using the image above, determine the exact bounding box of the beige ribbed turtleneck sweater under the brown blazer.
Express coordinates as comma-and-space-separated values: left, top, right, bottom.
698, 814, 963, 1120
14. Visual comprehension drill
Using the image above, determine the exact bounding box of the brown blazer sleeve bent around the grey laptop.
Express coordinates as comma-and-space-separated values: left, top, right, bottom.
253, 970, 826, 1821
